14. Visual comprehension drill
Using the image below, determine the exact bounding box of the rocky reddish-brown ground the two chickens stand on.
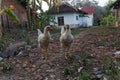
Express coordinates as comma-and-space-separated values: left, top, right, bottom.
0, 27, 120, 80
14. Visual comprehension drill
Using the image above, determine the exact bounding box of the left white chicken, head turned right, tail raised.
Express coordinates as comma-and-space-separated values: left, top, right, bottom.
38, 26, 52, 59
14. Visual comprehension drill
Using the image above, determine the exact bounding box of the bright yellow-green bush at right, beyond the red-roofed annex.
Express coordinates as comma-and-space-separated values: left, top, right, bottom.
101, 13, 117, 26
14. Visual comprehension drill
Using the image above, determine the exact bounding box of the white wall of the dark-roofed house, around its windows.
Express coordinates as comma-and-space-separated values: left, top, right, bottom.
50, 13, 87, 28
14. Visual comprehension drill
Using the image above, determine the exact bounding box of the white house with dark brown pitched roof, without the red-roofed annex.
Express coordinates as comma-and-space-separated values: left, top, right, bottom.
50, 3, 88, 28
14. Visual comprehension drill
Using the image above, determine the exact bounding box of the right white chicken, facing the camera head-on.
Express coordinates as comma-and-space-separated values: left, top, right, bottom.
60, 25, 74, 59
